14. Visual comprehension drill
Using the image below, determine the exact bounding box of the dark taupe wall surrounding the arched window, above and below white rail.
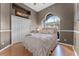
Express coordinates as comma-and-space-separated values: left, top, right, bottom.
37, 3, 74, 44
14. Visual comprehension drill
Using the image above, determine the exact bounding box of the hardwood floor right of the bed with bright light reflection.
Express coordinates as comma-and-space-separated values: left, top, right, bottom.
52, 44, 75, 56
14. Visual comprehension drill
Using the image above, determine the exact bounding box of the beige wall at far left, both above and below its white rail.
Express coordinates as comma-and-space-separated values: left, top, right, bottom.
0, 3, 11, 48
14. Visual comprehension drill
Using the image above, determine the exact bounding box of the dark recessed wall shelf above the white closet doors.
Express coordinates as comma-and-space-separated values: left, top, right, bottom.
12, 3, 31, 19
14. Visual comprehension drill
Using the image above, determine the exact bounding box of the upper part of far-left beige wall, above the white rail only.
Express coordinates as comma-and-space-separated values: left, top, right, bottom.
1, 3, 10, 30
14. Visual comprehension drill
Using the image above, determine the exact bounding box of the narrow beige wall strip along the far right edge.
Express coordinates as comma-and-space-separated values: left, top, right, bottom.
74, 4, 79, 56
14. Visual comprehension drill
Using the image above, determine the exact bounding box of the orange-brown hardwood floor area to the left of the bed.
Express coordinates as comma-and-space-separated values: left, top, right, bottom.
0, 43, 32, 56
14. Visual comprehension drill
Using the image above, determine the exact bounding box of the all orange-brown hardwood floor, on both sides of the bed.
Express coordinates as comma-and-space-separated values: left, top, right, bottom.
0, 43, 75, 56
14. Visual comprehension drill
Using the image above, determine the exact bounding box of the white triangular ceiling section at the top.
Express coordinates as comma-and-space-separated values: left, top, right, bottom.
24, 3, 55, 12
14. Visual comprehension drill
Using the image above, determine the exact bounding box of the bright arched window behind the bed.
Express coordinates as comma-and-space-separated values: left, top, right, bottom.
43, 14, 60, 41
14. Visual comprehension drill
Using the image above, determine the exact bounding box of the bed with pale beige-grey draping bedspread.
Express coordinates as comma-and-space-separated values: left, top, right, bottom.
23, 28, 57, 56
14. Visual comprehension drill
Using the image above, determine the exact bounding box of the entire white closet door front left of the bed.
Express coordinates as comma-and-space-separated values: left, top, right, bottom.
11, 15, 32, 43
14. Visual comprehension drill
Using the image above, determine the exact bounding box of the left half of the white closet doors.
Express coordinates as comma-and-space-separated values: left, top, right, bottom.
11, 16, 21, 43
